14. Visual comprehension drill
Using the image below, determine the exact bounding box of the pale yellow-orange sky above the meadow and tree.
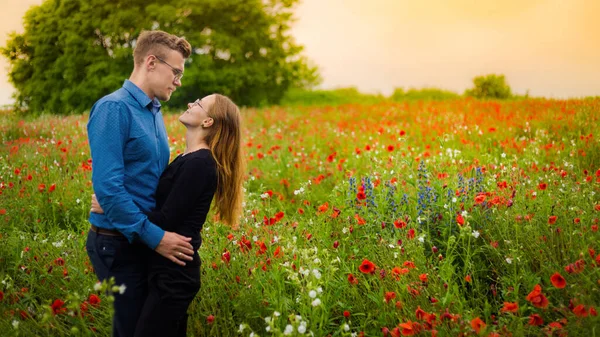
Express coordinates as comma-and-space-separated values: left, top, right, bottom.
0, 0, 600, 105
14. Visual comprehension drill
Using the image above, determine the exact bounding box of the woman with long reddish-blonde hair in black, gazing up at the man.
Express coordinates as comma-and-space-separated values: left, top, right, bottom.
92, 94, 244, 337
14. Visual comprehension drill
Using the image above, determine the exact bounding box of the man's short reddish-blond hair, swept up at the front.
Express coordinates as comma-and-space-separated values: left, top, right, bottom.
133, 30, 192, 65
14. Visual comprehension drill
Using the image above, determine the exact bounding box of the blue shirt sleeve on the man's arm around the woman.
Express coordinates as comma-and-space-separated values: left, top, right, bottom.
87, 101, 164, 249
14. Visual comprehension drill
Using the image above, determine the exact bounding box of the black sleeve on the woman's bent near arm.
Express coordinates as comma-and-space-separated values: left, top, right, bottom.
147, 158, 217, 228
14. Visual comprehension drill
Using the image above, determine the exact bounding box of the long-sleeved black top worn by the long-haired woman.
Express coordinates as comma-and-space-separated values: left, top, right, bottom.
147, 149, 217, 281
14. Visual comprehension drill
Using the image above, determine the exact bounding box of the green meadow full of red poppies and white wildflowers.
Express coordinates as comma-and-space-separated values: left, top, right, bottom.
0, 99, 600, 336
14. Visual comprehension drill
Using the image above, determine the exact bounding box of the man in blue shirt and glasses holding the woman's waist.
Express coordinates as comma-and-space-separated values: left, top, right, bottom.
86, 31, 194, 337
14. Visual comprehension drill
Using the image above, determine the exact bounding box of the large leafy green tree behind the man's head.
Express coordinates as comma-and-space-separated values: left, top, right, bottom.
1, 0, 319, 113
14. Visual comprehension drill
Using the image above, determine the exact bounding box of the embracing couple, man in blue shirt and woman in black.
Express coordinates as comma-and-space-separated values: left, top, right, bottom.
86, 31, 244, 337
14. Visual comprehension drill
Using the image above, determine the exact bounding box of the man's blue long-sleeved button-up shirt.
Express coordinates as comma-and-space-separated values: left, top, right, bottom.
87, 80, 170, 249
